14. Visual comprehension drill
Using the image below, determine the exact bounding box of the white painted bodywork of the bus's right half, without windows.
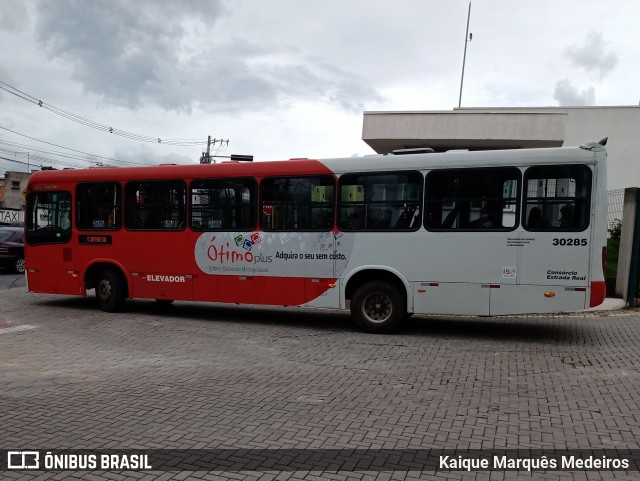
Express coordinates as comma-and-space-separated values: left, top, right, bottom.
323, 146, 606, 315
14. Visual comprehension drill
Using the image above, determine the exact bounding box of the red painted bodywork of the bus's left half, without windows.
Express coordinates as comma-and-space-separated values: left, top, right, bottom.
26, 160, 336, 306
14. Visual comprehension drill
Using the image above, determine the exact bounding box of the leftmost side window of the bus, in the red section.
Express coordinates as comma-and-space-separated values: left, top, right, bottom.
25, 191, 71, 245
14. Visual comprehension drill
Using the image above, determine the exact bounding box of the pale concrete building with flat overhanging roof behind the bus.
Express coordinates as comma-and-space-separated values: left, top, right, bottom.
362, 106, 640, 190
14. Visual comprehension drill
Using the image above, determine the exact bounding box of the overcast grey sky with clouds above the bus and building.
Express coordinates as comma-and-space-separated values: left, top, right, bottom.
0, 0, 640, 175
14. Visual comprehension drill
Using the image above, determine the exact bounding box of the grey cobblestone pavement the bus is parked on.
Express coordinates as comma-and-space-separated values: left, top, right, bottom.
0, 288, 640, 481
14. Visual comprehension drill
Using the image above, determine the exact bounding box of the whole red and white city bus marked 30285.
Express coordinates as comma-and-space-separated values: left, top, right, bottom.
25, 143, 607, 332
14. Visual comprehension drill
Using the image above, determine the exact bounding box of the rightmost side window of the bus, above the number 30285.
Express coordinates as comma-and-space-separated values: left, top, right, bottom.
522, 165, 591, 231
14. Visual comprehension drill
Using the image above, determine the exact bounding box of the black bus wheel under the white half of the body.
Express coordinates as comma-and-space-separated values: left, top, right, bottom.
351, 281, 407, 333
